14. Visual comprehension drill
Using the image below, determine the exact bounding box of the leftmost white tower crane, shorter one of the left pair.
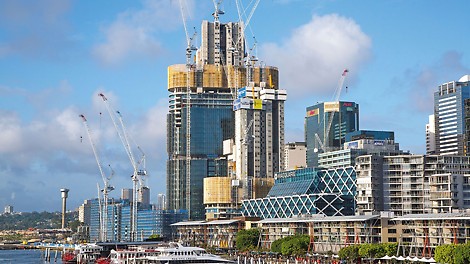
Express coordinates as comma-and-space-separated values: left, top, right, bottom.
80, 115, 114, 241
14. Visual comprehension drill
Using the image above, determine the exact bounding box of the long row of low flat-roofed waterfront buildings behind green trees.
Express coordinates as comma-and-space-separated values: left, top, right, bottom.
172, 211, 470, 259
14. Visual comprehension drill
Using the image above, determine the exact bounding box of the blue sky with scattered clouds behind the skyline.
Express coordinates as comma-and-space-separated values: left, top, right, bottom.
0, 0, 470, 211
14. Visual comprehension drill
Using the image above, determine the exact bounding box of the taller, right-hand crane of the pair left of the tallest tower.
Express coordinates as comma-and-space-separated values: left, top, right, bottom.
98, 93, 147, 241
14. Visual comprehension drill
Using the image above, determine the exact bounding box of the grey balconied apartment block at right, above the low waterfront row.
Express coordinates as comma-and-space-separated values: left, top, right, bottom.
356, 154, 470, 216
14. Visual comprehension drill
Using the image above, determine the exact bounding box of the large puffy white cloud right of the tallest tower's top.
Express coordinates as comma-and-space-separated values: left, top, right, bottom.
260, 14, 371, 99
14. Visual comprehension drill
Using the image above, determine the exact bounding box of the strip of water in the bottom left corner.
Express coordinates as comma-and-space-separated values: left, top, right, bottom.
0, 250, 62, 264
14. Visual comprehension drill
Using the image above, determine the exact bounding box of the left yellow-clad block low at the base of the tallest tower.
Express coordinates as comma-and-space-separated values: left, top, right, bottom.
203, 177, 232, 204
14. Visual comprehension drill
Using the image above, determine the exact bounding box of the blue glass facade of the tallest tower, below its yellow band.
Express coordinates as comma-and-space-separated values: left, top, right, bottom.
167, 89, 234, 219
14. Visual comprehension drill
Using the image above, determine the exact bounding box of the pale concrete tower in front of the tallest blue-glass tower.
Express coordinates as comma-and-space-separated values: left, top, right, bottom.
233, 80, 287, 199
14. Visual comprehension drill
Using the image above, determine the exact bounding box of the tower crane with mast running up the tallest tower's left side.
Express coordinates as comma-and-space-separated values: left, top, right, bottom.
179, 0, 197, 218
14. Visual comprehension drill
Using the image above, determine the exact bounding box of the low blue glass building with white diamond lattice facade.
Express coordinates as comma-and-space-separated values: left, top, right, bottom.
242, 167, 356, 219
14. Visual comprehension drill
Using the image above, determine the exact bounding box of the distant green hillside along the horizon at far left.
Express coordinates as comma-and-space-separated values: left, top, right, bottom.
0, 212, 77, 230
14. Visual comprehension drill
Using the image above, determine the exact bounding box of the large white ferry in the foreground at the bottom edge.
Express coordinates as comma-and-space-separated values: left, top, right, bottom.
110, 243, 235, 264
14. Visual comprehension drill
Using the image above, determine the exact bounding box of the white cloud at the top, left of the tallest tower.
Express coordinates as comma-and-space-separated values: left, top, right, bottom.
93, 0, 193, 65
